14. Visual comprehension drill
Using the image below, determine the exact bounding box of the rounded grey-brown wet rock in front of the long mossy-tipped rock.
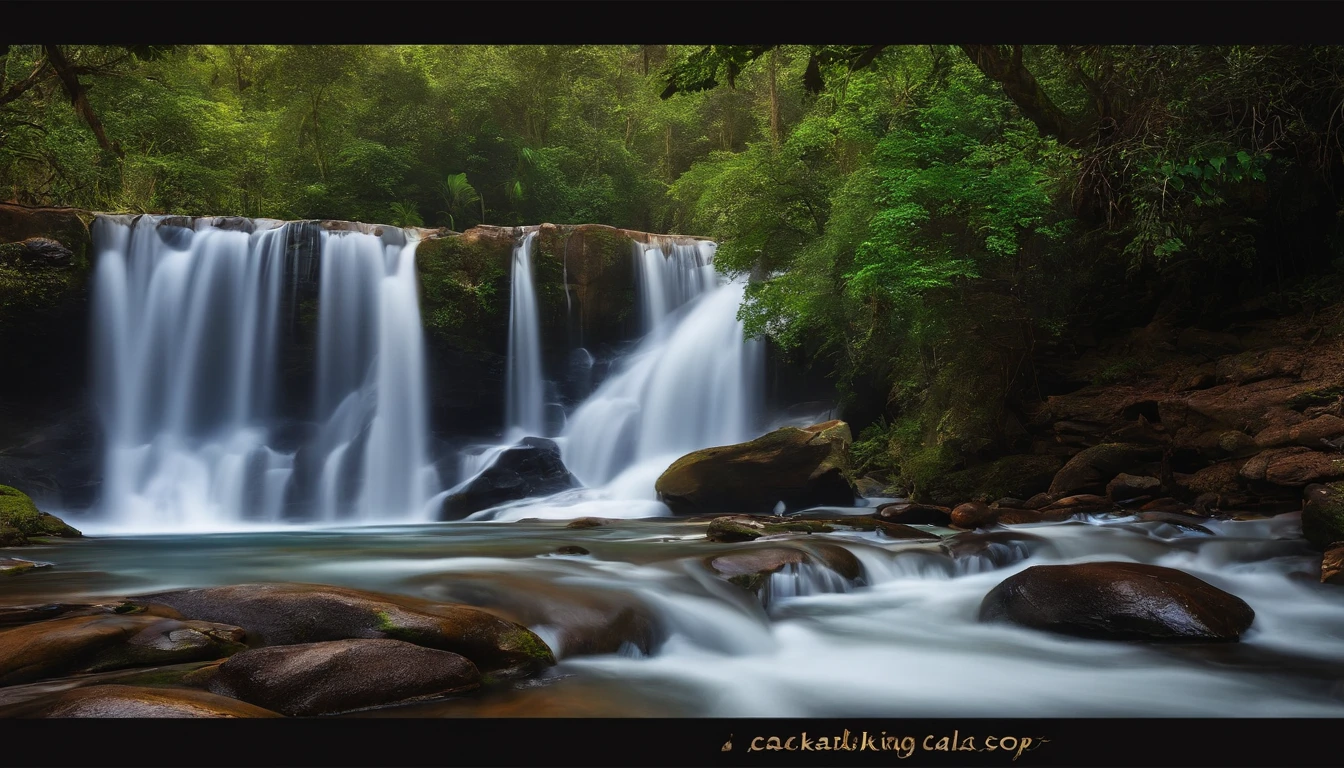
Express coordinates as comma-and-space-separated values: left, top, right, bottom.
208, 640, 481, 717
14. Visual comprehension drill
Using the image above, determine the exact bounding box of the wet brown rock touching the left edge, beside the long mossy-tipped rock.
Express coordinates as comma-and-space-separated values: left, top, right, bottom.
0, 615, 245, 685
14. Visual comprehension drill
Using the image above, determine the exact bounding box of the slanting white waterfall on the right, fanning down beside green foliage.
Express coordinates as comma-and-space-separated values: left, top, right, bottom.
563, 238, 763, 492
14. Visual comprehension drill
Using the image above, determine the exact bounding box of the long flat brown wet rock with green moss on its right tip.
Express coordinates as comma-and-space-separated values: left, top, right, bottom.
122, 584, 555, 673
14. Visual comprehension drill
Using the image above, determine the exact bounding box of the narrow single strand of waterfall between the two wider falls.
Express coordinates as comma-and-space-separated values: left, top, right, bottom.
504, 231, 546, 443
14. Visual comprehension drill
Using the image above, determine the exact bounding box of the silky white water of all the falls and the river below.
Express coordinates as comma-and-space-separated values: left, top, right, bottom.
0, 217, 1344, 717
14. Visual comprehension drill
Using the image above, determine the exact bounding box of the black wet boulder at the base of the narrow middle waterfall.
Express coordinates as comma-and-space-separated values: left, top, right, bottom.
441, 437, 579, 521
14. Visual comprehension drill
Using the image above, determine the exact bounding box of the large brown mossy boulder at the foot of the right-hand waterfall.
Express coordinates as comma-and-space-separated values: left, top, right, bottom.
655, 421, 855, 515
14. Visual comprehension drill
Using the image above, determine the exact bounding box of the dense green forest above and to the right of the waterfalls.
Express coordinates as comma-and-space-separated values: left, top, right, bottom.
0, 46, 1344, 497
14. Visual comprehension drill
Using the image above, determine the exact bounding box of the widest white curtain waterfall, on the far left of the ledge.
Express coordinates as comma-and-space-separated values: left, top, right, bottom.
93, 215, 437, 530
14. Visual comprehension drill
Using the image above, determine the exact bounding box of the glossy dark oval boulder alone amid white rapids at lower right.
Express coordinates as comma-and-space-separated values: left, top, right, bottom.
980, 562, 1255, 643
